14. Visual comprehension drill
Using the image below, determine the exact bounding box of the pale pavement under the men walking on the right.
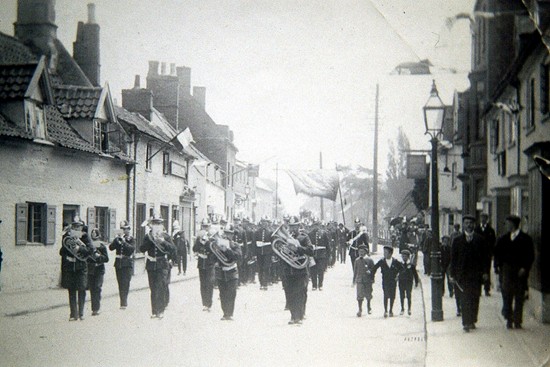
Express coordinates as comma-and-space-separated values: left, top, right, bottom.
418, 259, 550, 367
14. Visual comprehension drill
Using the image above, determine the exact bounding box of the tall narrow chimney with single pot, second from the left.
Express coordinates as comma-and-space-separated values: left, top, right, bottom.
73, 4, 100, 86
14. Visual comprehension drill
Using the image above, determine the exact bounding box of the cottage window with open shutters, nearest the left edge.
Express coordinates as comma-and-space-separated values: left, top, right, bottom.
15, 202, 56, 245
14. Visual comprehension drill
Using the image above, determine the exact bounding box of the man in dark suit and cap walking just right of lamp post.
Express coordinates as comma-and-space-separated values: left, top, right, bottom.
450, 215, 487, 332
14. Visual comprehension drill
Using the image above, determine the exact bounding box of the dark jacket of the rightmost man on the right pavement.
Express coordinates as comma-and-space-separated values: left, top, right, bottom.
495, 231, 535, 291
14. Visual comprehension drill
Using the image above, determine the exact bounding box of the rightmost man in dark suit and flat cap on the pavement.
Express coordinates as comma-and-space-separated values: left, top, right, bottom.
495, 215, 535, 329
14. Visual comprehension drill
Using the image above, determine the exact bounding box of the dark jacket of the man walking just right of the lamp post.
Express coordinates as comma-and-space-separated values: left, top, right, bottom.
449, 232, 487, 287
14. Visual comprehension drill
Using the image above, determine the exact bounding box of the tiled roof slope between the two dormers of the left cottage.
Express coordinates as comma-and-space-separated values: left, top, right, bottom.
45, 106, 101, 154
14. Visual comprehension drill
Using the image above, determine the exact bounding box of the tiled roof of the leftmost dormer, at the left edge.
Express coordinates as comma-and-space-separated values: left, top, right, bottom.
0, 64, 36, 100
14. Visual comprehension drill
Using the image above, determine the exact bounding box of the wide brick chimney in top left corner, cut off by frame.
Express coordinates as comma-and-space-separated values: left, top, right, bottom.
14, 0, 58, 72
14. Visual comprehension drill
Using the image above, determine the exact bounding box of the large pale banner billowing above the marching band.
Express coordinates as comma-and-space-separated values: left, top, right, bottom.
285, 169, 339, 201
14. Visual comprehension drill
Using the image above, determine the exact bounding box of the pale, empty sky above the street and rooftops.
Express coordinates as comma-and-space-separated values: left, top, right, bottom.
0, 0, 474, 216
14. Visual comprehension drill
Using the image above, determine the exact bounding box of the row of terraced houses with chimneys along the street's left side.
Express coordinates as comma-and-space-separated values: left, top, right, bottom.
0, 0, 272, 292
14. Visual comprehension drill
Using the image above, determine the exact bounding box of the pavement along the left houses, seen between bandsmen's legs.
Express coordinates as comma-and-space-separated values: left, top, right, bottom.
0, 258, 198, 317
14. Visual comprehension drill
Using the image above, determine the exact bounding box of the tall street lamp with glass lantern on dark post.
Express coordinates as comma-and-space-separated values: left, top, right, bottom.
423, 80, 445, 321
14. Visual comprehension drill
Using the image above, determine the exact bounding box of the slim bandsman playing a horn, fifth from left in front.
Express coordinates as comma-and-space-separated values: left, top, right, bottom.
193, 218, 216, 311
